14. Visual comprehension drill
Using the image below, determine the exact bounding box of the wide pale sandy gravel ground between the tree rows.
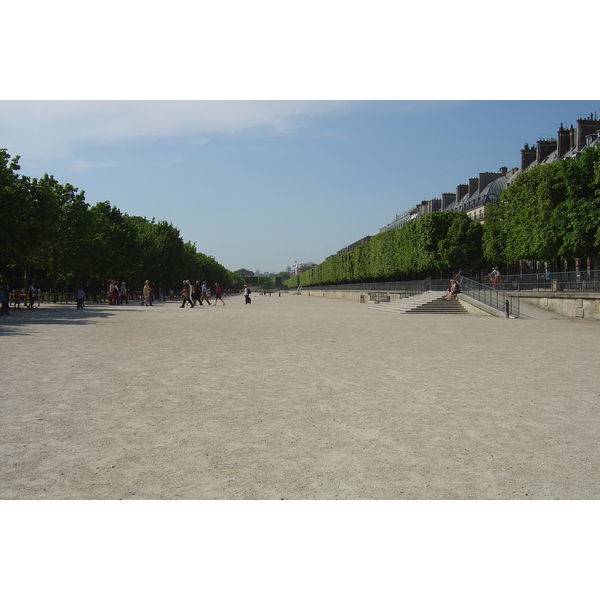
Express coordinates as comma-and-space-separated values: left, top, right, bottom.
0, 294, 600, 499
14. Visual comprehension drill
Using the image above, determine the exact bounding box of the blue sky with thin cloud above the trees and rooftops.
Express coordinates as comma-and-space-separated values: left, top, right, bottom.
0, 100, 600, 271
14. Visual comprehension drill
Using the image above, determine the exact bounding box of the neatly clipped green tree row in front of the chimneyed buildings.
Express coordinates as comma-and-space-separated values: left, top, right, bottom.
286, 143, 600, 287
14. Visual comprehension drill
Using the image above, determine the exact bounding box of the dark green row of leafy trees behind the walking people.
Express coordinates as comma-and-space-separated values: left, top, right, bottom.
0, 149, 243, 291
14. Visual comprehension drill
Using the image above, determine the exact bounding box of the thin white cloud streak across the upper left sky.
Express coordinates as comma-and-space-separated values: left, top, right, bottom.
0, 100, 353, 159
